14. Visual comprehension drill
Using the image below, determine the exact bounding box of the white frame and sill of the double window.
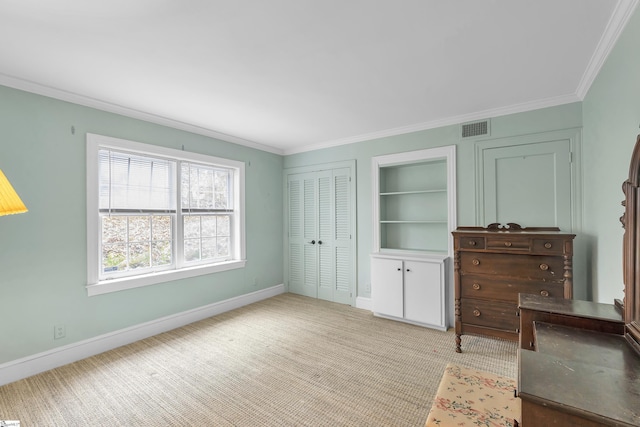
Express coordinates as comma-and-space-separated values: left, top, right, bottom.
86, 133, 246, 296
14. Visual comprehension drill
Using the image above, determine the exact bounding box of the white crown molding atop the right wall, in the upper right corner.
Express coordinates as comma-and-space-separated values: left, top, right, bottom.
576, 0, 639, 100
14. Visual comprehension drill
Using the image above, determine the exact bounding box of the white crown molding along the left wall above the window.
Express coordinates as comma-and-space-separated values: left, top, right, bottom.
0, 73, 283, 155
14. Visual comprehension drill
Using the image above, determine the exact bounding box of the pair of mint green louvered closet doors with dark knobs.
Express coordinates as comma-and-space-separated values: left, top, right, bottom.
288, 168, 353, 304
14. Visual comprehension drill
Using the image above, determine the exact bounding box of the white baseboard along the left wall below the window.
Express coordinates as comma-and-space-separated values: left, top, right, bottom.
0, 284, 285, 386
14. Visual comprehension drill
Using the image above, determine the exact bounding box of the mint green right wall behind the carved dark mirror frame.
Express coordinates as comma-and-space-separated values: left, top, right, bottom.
583, 5, 640, 302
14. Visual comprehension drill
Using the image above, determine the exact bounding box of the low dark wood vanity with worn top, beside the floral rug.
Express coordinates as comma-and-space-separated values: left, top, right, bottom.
518, 295, 640, 427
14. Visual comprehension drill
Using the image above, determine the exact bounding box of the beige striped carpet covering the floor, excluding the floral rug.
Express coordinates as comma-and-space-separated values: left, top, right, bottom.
0, 294, 516, 427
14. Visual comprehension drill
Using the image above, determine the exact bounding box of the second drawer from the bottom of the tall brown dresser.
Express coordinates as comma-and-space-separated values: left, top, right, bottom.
460, 275, 564, 303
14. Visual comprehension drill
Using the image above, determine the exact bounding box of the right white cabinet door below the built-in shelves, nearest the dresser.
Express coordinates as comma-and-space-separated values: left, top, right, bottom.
404, 261, 444, 326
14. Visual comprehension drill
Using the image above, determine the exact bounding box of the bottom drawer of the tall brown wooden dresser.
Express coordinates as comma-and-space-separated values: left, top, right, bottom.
461, 299, 520, 332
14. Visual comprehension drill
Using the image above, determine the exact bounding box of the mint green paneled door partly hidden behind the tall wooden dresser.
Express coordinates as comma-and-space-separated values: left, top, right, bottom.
480, 139, 572, 231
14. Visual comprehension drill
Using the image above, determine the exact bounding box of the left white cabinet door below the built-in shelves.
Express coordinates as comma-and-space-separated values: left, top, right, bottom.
371, 258, 404, 317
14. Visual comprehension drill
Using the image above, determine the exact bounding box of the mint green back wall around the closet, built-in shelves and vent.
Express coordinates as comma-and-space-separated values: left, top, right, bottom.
284, 103, 582, 306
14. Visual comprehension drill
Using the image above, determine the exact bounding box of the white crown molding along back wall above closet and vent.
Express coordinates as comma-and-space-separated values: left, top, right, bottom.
284, 94, 581, 155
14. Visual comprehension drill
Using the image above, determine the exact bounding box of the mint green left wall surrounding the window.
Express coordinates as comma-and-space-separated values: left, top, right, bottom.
0, 86, 283, 363
